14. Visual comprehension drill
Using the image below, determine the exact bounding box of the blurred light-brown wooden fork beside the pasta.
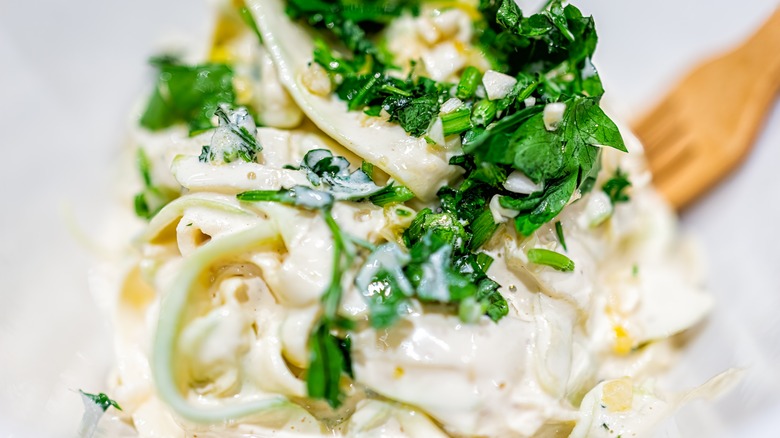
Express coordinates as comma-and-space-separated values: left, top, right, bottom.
633, 8, 780, 209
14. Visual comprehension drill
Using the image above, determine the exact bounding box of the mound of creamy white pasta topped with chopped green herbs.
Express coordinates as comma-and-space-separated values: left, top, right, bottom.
87, 0, 712, 437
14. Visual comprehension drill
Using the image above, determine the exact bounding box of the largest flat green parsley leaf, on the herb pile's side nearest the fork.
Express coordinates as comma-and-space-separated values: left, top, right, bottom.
464, 96, 625, 236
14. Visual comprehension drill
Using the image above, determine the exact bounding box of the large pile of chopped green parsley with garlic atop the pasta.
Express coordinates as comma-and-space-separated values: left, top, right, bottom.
287, 0, 626, 243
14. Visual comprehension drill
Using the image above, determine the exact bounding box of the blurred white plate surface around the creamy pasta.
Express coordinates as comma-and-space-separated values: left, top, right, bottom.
0, 0, 780, 438
